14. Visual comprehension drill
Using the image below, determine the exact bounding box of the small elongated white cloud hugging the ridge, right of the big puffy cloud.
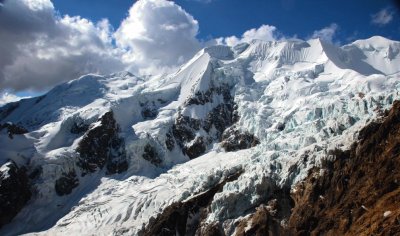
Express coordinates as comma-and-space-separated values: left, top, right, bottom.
216, 25, 279, 46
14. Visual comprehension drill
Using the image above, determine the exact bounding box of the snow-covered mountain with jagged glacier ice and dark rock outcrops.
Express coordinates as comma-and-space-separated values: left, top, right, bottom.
0, 37, 400, 235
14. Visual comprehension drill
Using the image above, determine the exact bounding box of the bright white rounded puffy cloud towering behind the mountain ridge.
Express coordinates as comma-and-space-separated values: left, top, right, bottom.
114, 0, 201, 73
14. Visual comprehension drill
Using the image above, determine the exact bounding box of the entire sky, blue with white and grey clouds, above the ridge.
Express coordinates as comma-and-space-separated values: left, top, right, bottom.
0, 0, 400, 105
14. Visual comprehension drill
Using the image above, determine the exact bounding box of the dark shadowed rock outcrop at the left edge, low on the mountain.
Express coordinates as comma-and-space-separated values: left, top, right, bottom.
0, 161, 31, 227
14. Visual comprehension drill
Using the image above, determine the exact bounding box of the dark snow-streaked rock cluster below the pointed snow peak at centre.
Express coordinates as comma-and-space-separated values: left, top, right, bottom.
170, 85, 258, 159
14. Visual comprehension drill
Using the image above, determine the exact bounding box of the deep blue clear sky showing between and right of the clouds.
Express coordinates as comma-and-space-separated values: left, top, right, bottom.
53, 0, 400, 44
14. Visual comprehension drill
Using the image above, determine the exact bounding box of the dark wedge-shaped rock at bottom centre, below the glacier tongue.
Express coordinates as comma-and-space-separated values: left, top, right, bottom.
138, 170, 243, 236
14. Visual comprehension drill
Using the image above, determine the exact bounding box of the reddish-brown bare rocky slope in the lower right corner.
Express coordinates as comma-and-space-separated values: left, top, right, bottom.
288, 102, 400, 235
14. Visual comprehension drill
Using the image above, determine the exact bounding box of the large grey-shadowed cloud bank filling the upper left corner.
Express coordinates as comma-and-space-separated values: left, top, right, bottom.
0, 0, 124, 90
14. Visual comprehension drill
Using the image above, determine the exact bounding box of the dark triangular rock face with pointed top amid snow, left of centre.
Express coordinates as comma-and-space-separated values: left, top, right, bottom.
77, 111, 128, 174
